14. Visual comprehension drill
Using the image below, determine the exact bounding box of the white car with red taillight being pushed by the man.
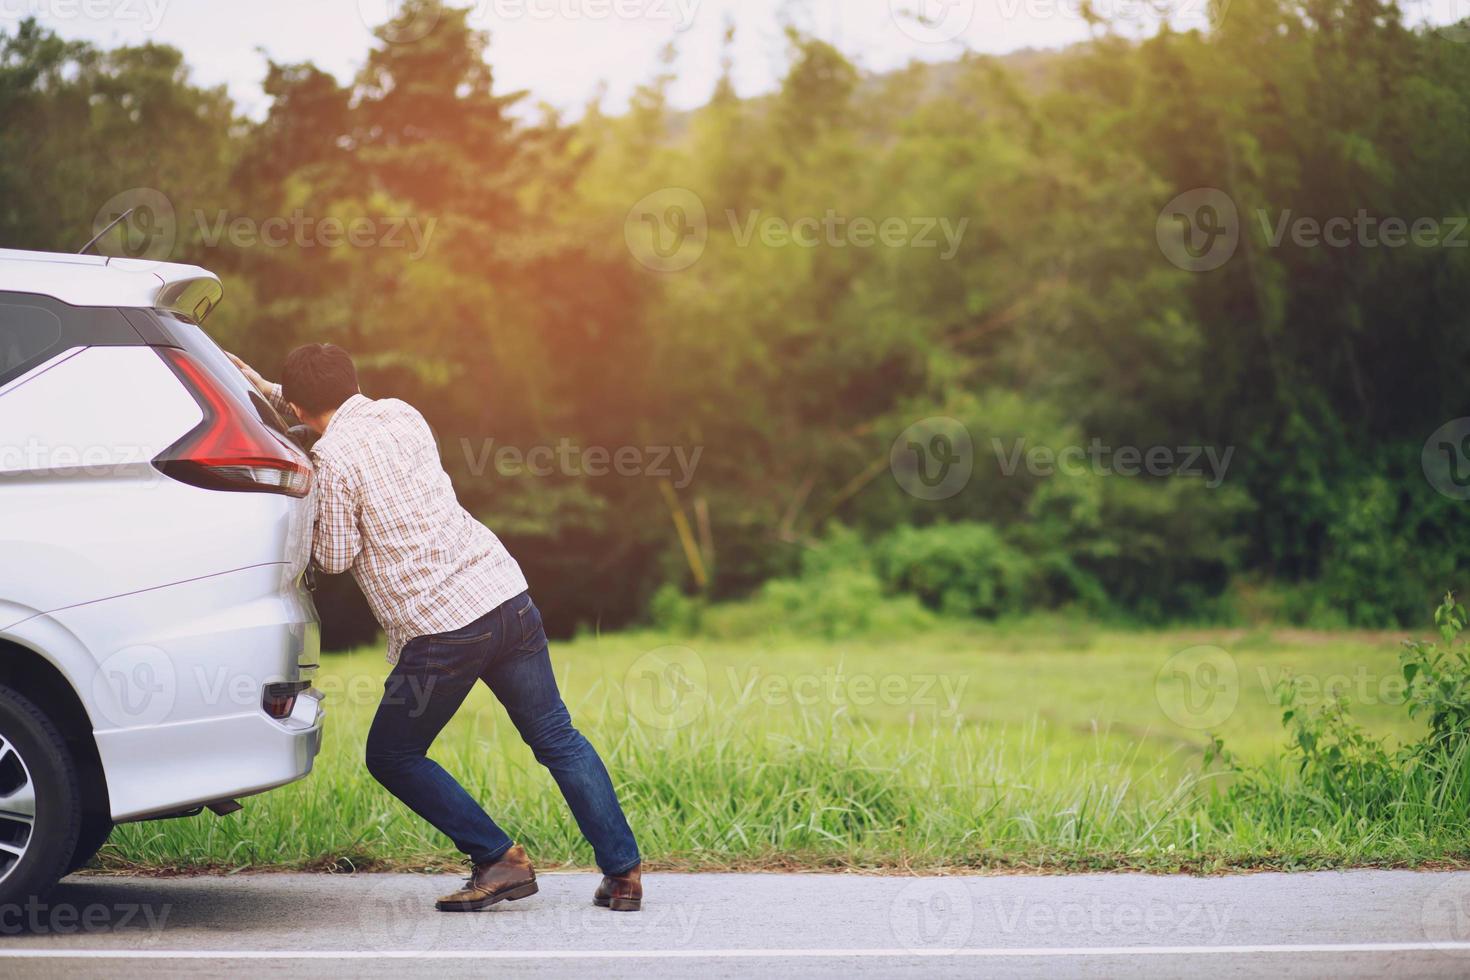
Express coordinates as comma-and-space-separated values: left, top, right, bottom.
0, 250, 322, 905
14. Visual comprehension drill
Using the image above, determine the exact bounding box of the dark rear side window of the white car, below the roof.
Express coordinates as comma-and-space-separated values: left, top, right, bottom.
0, 292, 143, 386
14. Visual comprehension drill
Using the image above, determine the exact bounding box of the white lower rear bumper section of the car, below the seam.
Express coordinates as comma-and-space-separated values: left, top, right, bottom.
7, 564, 323, 823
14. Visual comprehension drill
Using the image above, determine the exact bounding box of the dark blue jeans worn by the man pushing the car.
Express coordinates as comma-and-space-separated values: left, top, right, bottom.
368, 592, 639, 874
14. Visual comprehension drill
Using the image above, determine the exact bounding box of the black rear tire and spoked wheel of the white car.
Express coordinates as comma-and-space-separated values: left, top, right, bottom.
0, 686, 82, 908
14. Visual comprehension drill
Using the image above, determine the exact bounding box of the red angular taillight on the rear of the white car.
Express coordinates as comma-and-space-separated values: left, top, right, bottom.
153, 347, 312, 497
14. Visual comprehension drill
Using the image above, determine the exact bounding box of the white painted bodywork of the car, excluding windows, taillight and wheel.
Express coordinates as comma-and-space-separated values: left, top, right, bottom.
0, 250, 323, 821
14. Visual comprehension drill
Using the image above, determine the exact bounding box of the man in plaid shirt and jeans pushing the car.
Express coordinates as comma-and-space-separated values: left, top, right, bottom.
231, 344, 642, 912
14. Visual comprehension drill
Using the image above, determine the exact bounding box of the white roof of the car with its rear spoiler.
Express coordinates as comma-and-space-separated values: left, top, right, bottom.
0, 248, 223, 322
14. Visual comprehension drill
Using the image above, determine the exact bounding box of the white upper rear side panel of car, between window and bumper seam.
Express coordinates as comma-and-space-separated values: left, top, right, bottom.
0, 347, 313, 611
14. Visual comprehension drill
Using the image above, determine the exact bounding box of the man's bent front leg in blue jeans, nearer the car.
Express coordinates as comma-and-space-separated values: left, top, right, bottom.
368, 614, 512, 864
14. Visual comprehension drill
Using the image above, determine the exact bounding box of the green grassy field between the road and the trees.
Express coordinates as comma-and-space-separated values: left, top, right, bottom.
101, 620, 1470, 870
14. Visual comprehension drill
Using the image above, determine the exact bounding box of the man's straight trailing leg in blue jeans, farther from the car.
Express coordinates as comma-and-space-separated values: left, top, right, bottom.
482, 595, 639, 874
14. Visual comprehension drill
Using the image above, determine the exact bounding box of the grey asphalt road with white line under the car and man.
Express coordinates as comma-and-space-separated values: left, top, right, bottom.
0, 871, 1470, 980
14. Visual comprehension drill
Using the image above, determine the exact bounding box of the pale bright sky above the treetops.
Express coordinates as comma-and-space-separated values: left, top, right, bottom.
0, 0, 1470, 118
